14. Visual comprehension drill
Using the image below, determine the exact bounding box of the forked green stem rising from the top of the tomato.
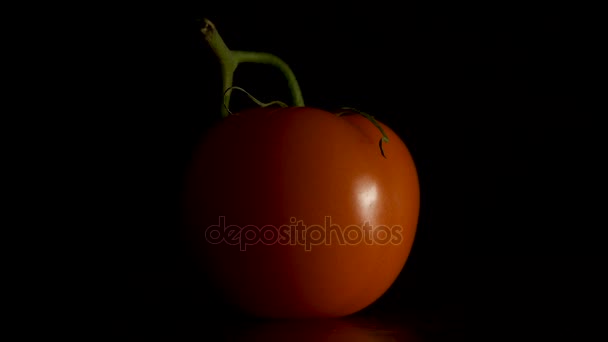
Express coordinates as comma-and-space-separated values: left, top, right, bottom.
201, 19, 304, 117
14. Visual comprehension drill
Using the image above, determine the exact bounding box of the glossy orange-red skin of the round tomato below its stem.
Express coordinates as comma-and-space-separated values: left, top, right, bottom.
185, 107, 420, 318
